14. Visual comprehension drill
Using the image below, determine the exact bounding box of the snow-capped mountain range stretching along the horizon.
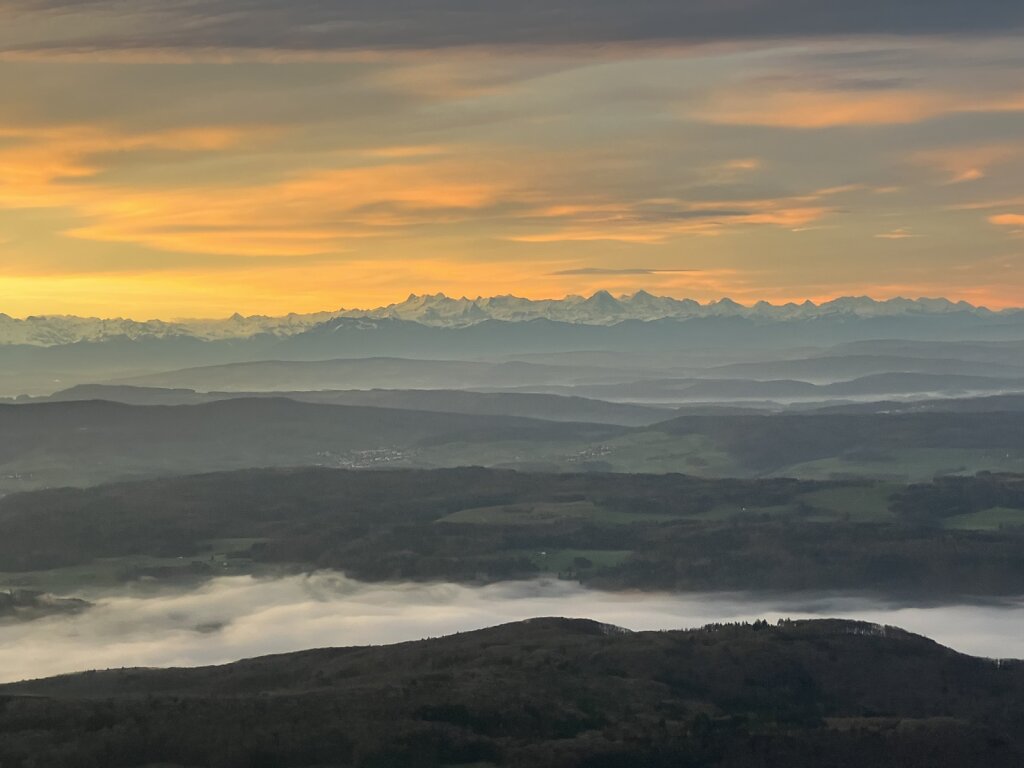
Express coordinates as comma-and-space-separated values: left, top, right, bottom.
0, 291, 1022, 346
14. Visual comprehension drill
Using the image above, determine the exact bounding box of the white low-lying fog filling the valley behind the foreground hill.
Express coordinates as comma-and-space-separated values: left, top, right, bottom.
0, 572, 1024, 681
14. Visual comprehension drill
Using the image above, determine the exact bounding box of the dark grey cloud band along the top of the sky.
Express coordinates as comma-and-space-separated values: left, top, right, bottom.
0, 0, 1024, 55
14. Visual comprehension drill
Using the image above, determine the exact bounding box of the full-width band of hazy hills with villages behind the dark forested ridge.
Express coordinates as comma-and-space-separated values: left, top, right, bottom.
0, 397, 1024, 493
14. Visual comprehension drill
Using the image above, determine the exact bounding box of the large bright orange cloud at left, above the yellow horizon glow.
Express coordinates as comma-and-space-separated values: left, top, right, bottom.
0, 124, 518, 257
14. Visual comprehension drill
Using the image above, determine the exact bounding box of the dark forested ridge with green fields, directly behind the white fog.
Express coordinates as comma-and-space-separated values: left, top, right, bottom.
0, 468, 1024, 597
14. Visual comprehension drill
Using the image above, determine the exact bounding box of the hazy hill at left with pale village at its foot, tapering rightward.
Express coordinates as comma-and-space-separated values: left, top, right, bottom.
0, 397, 623, 490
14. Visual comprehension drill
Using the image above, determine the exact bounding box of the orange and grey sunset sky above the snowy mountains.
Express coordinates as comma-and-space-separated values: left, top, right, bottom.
0, 0, 1024, 318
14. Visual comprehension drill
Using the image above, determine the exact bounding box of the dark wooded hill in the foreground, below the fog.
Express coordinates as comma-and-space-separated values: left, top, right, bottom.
0, 618, 1024, 768
